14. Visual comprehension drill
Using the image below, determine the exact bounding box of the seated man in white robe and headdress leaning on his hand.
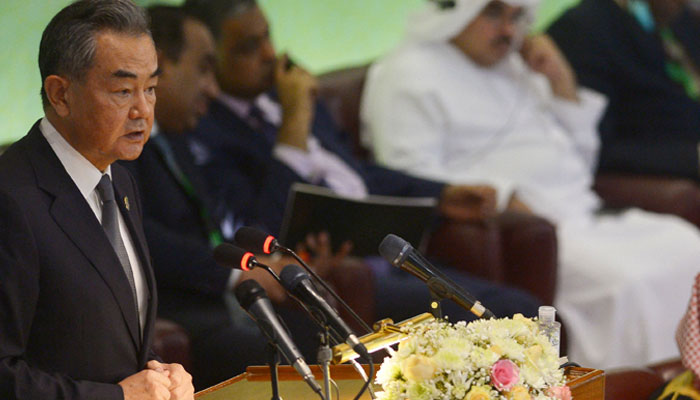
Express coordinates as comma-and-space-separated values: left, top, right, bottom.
361, 0, 700, 368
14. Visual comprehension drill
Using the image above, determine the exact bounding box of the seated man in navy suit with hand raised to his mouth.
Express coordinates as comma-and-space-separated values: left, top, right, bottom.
185, 0, 537, 321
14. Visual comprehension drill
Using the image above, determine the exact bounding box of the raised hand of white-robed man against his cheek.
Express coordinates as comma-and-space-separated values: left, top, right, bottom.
520, 35, 578, 101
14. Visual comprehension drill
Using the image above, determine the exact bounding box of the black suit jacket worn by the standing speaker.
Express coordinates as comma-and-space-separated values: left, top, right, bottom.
0, 123, 157, 399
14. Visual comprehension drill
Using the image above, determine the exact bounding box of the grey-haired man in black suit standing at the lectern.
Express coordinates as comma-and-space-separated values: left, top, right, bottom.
0, 0, 194, 400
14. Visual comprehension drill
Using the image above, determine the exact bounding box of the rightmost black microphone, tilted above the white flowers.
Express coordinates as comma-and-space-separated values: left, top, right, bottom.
379, 234, 494, 318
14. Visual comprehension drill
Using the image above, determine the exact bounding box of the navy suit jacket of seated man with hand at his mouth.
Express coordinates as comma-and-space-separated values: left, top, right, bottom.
192, 101, 444, 232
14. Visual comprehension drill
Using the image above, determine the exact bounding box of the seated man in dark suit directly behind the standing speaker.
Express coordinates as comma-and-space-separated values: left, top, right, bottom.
123, 6, 334, 390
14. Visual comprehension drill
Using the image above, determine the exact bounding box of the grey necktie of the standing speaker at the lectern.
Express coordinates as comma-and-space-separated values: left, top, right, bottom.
97, 174, 141, 323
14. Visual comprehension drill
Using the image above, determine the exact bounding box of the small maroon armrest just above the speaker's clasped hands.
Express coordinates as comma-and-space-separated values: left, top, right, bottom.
153, 318, 192, 371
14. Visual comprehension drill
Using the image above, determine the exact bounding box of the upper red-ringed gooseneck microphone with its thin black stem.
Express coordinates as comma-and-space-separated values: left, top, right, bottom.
234, 226, 374, 333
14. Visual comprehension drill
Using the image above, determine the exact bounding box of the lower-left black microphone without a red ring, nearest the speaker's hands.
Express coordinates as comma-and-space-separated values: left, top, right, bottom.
236, 280, 323, 398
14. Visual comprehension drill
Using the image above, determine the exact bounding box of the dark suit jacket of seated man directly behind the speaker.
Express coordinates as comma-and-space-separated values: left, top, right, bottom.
121, 133, 231, 300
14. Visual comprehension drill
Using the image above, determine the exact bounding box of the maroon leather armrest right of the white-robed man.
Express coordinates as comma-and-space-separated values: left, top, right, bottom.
594, 174, 700, 227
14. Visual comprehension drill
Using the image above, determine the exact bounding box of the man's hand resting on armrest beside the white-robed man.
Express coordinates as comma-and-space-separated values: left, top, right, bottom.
438, 185, 496, 221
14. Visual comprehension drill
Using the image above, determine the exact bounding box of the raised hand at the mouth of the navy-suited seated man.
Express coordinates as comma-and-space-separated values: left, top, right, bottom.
275, 55, 318, 150
